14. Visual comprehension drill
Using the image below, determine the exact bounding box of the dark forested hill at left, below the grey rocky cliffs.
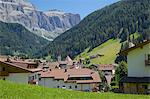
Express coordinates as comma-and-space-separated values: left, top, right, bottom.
0, 21, 48, 55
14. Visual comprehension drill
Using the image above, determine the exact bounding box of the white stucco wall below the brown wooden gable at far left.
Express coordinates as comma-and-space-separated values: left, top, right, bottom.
5, 73, 30, 84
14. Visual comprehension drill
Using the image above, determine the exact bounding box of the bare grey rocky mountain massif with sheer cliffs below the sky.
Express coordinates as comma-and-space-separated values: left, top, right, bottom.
0, 0, 80, 40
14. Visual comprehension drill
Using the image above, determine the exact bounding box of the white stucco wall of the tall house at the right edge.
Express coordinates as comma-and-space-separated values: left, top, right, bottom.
127, 44, 150, 77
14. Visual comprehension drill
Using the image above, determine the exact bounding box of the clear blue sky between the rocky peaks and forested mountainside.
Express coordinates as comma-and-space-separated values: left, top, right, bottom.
29, 0, 119, 18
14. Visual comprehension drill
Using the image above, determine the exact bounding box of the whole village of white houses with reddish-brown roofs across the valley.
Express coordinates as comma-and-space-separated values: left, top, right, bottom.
0, 40, 150, 94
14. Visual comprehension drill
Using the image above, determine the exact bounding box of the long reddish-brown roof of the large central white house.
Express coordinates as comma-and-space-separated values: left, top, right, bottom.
40, 68, 101, 83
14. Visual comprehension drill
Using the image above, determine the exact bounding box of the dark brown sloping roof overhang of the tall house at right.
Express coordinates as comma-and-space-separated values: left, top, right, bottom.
118, 40, 150, 55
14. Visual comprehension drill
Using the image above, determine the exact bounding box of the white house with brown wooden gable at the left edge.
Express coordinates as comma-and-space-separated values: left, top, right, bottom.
0, 61, 41, 84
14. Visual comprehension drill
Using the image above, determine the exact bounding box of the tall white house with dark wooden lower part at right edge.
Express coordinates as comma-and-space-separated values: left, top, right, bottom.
119, 40, 150, 94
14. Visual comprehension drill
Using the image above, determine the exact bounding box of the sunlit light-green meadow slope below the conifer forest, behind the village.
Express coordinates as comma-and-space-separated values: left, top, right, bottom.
76, 39, 121, 64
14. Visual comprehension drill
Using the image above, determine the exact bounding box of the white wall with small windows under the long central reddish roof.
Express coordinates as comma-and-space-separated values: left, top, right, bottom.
39, 78, 92, 91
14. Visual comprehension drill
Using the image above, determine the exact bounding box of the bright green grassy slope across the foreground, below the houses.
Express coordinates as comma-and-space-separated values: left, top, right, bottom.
0, 80, 150, 99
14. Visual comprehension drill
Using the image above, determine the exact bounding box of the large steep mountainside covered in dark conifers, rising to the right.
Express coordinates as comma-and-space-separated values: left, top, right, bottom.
35, 0, 150, 58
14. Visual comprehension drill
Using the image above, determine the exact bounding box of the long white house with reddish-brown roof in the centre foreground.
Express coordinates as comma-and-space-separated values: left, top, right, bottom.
39, 69, 101, 91
